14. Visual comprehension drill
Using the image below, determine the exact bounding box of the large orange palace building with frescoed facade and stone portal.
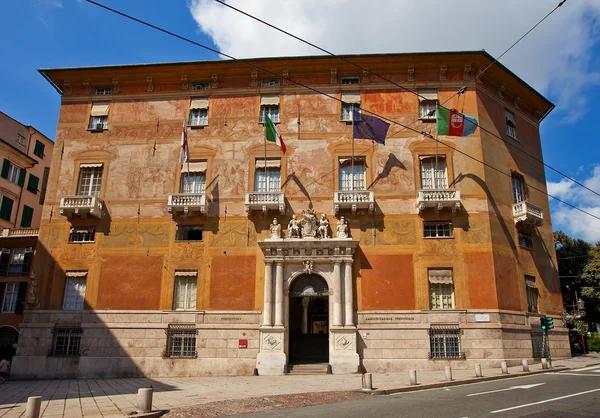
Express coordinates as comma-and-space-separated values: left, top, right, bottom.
12, 51, 570, 378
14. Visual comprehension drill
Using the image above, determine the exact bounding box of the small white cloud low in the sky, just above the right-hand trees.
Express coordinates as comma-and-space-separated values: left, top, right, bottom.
548, 165, 600, 243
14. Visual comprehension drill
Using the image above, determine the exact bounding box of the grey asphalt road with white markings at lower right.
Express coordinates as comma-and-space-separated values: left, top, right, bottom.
237, 366, 600, 418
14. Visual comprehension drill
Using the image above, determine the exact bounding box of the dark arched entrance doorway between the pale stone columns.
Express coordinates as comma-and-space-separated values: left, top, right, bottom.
289, 274, 329, 364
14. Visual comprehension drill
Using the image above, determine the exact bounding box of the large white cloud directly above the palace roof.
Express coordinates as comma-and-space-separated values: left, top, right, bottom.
189, 0, 600, 121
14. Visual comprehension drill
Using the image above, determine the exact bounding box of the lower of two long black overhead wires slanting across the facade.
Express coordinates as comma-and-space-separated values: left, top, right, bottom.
86, 0, 600, 224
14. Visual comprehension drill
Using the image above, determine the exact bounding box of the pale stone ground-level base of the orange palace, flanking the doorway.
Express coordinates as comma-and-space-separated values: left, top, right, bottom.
11, 310, 570, 379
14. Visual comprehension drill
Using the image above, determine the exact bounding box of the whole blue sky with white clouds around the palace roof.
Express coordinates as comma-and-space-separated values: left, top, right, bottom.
0, 0, 600, 241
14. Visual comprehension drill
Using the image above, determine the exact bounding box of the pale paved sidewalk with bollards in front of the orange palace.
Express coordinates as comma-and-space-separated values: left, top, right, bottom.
0, 354, 600, 418
